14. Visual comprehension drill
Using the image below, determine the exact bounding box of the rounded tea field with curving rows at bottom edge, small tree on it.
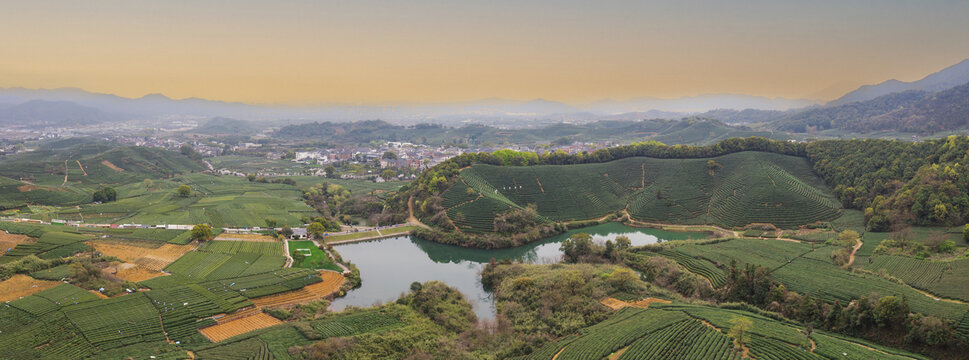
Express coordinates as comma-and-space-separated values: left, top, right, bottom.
523, 303, 922, 360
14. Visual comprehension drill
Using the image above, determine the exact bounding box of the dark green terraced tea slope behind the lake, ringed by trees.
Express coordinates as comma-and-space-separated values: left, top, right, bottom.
443, 152, 842, 232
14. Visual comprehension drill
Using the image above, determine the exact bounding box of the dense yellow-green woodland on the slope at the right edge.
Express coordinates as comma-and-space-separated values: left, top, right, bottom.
807, 136, 969, 231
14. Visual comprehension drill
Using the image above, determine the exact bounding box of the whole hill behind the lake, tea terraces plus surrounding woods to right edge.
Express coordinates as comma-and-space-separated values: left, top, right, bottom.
391, 136, 969, 247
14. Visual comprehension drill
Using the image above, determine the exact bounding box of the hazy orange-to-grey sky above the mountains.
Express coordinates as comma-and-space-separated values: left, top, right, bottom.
0, 0, 969, 104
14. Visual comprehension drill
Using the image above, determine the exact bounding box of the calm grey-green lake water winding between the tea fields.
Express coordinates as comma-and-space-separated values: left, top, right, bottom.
330, 223, 706, 318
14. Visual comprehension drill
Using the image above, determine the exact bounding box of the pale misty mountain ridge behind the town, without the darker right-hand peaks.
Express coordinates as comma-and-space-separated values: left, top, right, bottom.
0, 88, 813, 126
